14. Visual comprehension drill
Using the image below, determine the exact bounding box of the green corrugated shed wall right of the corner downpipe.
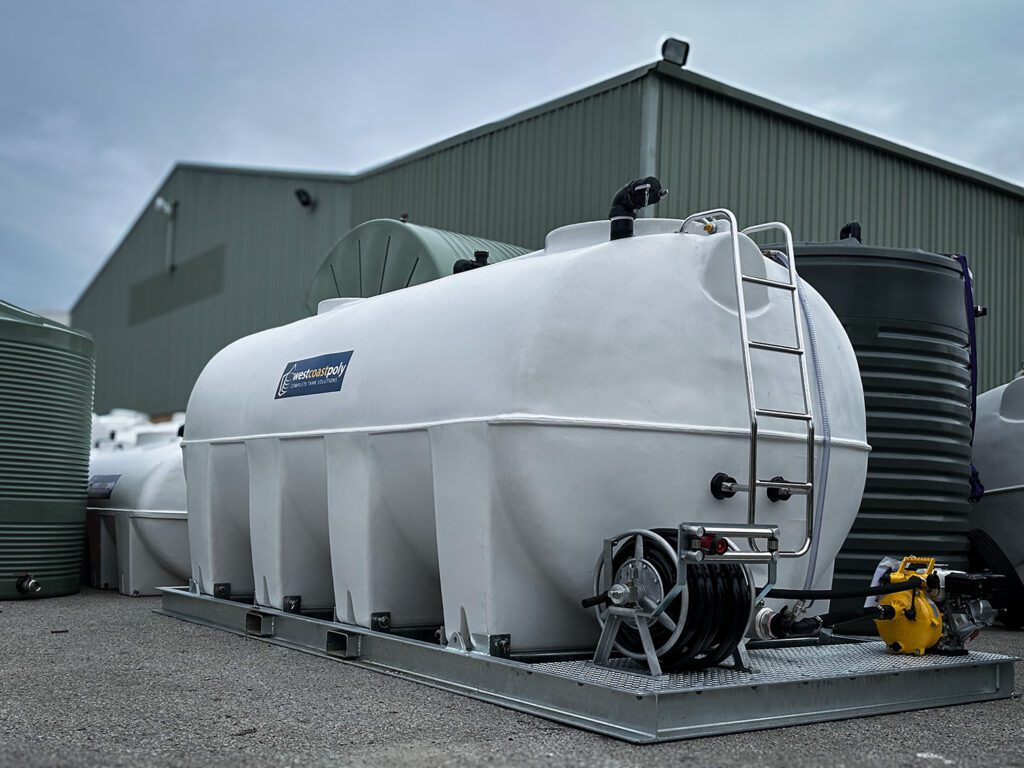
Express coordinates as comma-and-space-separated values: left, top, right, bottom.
657, 78, 1024, 390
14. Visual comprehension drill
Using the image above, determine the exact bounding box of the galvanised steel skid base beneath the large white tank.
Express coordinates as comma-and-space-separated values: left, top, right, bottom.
158, 588, 1014, 742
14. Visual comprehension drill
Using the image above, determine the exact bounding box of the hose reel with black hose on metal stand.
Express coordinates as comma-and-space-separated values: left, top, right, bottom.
582, 523, 778, 677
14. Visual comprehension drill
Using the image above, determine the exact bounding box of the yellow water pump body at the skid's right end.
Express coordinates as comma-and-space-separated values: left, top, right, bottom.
874, 557, 942, 656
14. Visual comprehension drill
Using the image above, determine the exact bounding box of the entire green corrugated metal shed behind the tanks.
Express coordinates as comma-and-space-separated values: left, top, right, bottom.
73, 61, 1024, 413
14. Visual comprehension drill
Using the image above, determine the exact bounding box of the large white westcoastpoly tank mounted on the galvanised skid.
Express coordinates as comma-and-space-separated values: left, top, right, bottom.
184, 219, 868, 651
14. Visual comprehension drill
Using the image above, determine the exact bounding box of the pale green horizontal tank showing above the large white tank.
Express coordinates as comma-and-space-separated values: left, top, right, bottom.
306, 219, 527, 314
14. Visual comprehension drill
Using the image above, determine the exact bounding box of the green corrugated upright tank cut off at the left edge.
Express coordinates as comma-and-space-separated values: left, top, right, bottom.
0, 301, 94, 599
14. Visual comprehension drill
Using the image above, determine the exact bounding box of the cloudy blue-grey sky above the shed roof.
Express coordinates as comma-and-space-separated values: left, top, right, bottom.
0, 0, 1024, 309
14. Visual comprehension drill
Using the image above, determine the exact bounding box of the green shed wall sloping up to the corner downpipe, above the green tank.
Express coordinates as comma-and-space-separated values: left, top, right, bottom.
352, 80, 642, 248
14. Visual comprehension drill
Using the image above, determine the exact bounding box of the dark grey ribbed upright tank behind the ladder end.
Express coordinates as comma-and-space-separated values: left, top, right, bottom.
796, 240, 971, 608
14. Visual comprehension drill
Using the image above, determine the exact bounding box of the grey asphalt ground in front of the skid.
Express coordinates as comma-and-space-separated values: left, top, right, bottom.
0, 589, 1024, 768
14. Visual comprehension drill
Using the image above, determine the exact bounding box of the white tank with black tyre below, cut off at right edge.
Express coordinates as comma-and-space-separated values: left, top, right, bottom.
971, 373, 1024, 627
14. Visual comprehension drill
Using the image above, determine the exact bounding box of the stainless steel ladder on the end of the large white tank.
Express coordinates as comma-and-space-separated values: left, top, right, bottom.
679, 208, 814, 557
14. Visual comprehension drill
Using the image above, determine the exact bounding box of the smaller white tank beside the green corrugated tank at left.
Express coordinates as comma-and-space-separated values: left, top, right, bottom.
86, 431, 190, 596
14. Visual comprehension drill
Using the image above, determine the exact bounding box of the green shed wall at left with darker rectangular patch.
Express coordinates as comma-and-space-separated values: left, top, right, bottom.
73, 166, 351, 414
